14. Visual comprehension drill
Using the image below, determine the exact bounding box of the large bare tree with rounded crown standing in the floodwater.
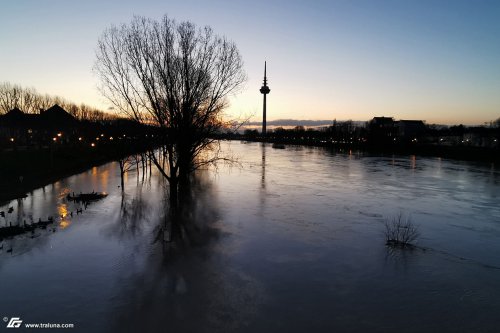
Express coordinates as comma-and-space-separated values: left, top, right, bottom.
95, 16, 246, 201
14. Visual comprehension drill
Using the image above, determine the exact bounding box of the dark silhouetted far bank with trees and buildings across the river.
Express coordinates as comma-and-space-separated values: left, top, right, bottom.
235, 117, 500, 161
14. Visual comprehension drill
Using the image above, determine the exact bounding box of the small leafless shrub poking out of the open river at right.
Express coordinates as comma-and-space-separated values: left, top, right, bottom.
385, 213, 420, 247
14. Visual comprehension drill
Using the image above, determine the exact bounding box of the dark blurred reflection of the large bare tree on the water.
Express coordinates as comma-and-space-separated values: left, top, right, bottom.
110, 170, 264, 332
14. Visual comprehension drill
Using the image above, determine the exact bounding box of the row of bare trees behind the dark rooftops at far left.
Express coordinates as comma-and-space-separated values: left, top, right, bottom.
0, 82, 117, 122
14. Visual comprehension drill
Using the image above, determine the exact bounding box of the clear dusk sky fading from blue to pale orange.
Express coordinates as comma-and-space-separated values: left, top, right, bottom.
0, 0, 500, 124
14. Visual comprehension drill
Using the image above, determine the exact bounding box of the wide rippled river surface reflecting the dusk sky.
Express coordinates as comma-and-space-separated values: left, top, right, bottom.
0, 142, 500, 332
